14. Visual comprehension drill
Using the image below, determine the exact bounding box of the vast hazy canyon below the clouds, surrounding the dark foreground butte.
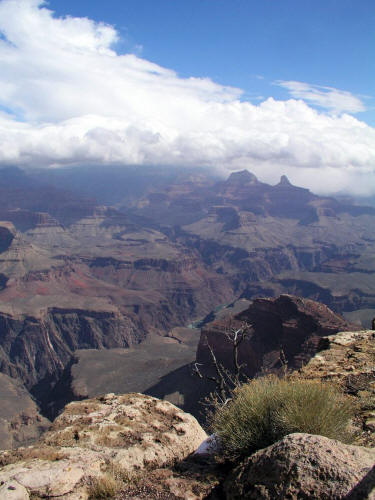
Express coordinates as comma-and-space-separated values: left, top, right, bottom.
0, 168, 375, 444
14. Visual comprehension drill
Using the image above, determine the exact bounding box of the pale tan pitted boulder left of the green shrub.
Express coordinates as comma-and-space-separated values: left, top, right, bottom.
42, 394, 206, 470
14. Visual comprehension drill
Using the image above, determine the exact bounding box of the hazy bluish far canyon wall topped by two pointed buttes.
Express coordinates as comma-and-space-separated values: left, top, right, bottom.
136, 171, 375, 320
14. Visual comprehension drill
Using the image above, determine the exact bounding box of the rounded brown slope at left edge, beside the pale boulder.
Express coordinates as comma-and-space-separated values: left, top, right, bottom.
0, 373, 50, 452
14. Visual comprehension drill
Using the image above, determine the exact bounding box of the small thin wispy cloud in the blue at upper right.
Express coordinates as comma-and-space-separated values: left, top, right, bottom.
275, 80, 366, 114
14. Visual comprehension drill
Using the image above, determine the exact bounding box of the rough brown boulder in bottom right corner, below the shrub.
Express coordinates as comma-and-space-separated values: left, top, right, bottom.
225, 434, 375, 500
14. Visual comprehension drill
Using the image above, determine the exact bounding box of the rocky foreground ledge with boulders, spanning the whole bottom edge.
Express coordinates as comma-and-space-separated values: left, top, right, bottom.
0, 394, 375, 500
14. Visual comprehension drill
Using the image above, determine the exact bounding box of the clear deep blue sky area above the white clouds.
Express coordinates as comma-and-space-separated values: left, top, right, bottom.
49, 0, 375, 125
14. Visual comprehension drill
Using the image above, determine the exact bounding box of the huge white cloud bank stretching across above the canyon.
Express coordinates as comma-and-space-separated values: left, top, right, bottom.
0, 0, 375, 194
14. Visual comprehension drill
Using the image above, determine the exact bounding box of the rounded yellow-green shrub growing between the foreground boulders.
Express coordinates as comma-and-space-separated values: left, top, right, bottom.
212, 376, 354, 459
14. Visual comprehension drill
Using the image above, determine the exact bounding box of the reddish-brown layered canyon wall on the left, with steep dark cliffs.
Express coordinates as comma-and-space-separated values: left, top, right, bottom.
0, 214, 233, 405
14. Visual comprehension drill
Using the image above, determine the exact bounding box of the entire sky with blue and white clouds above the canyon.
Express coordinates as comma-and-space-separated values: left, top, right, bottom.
0, 0, 375, 196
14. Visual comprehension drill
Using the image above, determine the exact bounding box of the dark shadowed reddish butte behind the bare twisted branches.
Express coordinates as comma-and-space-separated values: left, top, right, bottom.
197, 295, 359, 377
